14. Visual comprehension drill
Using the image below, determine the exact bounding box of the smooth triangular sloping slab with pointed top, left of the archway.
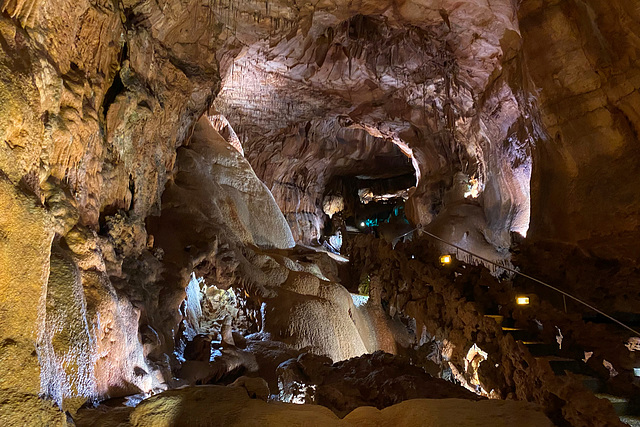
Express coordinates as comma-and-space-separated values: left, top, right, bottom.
152, 116, 294, 252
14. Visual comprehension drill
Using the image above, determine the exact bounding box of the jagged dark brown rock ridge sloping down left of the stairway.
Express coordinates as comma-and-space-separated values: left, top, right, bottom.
349, 237, 620, 426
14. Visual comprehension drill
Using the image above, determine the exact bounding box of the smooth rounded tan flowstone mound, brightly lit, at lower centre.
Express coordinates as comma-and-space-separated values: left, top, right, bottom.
242, 247, 408, 362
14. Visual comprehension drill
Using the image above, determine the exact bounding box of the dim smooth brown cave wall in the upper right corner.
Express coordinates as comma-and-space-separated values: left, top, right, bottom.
519, 0, 640, 259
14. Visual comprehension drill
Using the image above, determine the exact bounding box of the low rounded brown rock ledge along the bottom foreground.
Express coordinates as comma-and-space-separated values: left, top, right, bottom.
75, 386, 553, 427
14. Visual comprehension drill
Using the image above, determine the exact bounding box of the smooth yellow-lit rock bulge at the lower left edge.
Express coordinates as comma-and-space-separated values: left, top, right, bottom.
0, 176, 65, 425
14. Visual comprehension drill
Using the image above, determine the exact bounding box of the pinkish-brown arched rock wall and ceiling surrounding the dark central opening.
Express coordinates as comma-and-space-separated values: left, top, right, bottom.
214, 10, 534, 261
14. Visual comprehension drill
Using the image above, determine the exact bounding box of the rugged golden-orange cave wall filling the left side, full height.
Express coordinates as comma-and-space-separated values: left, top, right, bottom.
0, 0, 219, 424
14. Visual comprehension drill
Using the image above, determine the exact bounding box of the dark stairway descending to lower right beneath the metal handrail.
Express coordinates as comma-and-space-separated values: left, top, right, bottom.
485, 314, 640, 427
